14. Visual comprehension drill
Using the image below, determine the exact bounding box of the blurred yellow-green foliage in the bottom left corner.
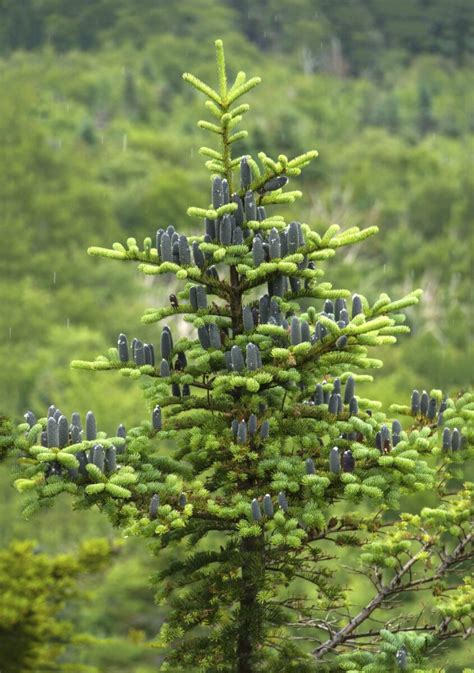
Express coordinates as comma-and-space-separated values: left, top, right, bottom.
0, 539, 114, 673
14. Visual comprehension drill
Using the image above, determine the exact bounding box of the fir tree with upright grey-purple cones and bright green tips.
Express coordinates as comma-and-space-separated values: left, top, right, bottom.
9, 41, 474, 673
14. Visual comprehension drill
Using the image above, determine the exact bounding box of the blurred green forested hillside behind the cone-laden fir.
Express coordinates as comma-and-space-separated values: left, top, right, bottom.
0, 0, 474, 673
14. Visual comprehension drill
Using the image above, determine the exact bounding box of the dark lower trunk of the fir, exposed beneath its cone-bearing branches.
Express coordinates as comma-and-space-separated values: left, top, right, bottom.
237, 535, 265, 673
